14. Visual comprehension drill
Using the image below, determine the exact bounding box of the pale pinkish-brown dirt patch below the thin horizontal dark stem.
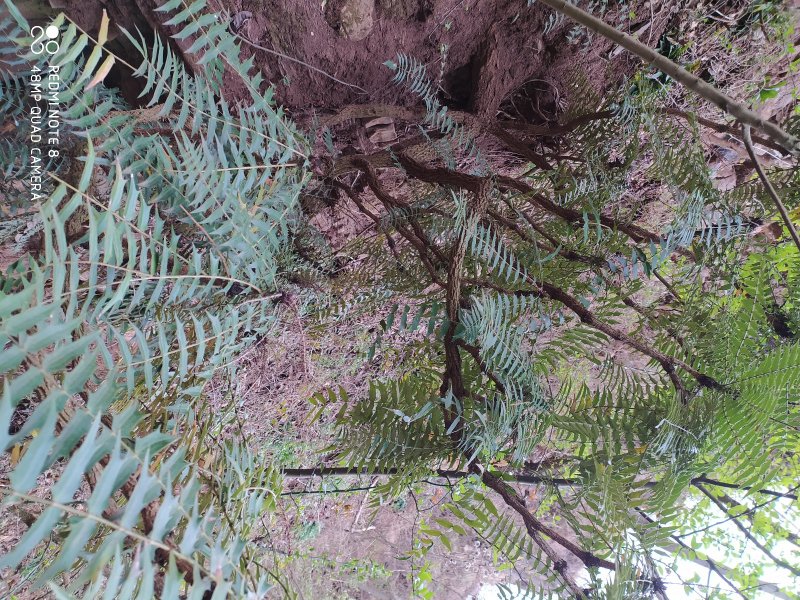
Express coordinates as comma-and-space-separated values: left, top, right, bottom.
275, 478, 581, 600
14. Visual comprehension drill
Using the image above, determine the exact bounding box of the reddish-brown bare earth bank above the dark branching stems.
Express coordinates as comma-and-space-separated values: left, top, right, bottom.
220, 0, 663, 116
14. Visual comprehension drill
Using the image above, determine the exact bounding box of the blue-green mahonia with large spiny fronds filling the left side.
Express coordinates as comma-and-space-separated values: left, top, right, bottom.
0, 0, 308, 598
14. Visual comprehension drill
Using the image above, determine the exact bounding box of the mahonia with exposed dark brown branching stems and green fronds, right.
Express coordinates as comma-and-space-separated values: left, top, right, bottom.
306, 45, 800, 598
